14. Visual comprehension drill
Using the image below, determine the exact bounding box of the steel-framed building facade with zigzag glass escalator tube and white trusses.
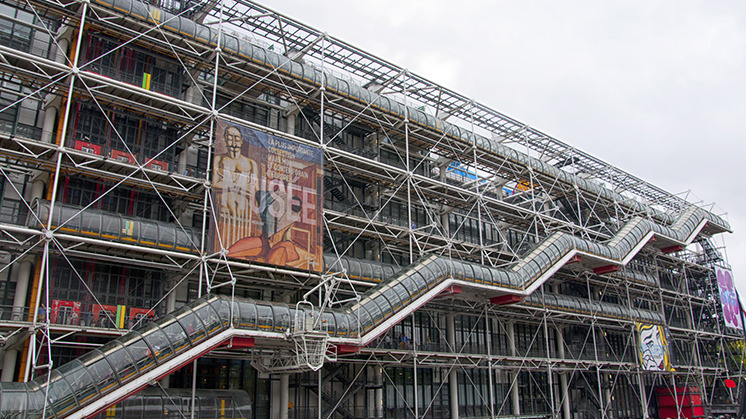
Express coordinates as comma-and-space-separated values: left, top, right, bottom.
0, 0, 745, 419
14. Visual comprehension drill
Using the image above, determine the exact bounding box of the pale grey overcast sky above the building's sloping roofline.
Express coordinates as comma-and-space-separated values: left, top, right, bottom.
265, 0, 746, 297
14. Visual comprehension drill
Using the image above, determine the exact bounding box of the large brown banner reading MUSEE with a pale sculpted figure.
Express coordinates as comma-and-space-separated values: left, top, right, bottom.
211, 121, 324, 272
